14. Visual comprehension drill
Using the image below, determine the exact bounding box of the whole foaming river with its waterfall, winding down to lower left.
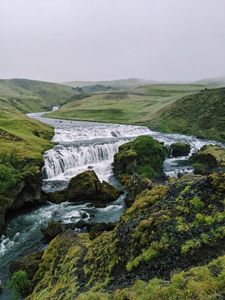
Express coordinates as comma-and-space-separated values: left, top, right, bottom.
0, 113, 221, 300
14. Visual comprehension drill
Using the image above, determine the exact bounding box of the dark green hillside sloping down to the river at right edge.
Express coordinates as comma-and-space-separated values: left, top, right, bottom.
147, 88, 225, 141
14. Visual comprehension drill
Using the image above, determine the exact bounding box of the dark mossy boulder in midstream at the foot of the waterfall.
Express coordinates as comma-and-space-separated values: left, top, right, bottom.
66, 171, 120, 207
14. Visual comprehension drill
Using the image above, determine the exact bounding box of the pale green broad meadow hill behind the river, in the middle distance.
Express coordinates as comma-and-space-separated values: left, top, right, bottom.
45, 84, 203, 124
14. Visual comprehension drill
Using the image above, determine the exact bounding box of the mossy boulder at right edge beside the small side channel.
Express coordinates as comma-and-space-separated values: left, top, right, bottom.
189, 145, 225, 175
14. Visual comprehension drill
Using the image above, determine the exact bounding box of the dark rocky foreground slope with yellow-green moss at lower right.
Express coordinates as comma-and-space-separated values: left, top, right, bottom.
10, 137, 225, 300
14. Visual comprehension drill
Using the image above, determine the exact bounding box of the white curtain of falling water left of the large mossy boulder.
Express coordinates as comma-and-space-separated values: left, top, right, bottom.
44, 139, 128, 180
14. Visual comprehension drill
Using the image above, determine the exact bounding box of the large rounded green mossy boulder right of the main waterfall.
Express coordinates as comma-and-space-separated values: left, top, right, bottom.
114, 136, 167, 179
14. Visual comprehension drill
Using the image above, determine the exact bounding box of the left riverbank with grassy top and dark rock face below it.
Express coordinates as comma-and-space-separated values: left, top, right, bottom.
0, 109, 53, 233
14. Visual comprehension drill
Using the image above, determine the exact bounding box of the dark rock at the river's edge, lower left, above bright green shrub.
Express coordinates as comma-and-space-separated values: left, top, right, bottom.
10, 251, 43, 279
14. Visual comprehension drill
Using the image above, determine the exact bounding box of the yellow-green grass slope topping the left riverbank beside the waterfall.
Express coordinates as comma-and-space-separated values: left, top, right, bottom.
0, 109, 53, 196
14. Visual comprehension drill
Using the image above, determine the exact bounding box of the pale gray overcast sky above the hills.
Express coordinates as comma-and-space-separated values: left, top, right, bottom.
0, 0, 225, 81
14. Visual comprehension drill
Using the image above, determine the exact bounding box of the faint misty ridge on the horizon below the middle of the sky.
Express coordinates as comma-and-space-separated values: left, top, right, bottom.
63, 78, 155, 88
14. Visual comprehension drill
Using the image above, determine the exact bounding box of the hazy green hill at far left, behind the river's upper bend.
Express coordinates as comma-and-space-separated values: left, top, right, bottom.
0, 79, 78, 112
